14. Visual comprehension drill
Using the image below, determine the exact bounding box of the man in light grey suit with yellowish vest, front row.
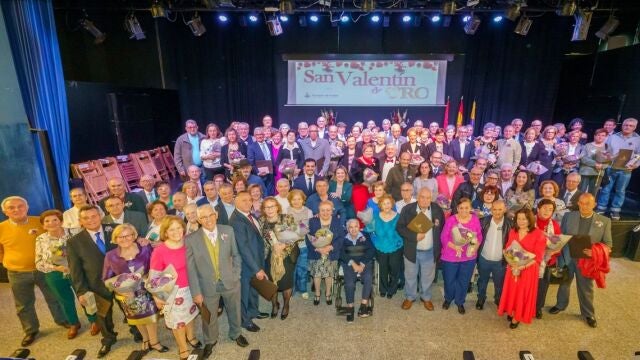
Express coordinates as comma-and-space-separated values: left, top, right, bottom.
185, 204, 249, 359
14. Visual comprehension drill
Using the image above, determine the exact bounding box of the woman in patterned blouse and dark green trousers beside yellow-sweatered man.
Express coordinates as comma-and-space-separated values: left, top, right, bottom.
36, 210, 82, 340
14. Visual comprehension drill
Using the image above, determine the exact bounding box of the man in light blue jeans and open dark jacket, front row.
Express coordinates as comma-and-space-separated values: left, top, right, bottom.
396, 187, 444, 311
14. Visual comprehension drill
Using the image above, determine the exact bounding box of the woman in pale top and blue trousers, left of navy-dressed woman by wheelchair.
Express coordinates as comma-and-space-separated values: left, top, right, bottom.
287, 189, 313, 300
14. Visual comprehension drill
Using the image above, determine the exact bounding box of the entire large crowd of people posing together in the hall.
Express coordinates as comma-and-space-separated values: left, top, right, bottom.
0, 116, 640, 358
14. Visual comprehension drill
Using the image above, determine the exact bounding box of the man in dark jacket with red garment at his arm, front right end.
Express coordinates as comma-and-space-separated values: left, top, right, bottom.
549, 193, 613, 328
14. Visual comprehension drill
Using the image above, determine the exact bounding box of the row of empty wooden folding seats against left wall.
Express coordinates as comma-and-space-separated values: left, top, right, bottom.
71, 145, 177, 203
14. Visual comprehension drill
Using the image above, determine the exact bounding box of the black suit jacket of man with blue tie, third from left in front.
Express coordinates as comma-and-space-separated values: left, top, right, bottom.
67, 224, 117, 300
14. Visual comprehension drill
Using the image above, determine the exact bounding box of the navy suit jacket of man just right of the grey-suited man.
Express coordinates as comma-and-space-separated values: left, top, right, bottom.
229, 209, 265, 274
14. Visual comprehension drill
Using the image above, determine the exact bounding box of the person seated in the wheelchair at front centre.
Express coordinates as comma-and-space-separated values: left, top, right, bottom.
340, 219, 376, 322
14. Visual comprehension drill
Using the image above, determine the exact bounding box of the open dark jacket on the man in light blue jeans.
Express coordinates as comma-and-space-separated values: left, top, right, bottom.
396, 202, 444, 264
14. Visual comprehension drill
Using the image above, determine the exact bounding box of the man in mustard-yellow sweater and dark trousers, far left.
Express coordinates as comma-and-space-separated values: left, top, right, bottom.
0, 196, 71, 347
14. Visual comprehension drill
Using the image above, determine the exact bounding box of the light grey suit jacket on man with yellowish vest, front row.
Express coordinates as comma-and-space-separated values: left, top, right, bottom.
185, 225, 242, 297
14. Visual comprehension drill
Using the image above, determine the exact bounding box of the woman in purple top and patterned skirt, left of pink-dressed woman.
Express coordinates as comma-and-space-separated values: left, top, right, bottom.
102, 223, 169, 353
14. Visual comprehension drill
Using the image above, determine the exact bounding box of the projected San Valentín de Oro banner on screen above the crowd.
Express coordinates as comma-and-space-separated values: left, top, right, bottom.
287, 60, 447, 106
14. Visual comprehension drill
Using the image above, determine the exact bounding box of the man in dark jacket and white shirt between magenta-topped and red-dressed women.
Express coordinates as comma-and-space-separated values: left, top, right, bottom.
476, 199, 511, 310
